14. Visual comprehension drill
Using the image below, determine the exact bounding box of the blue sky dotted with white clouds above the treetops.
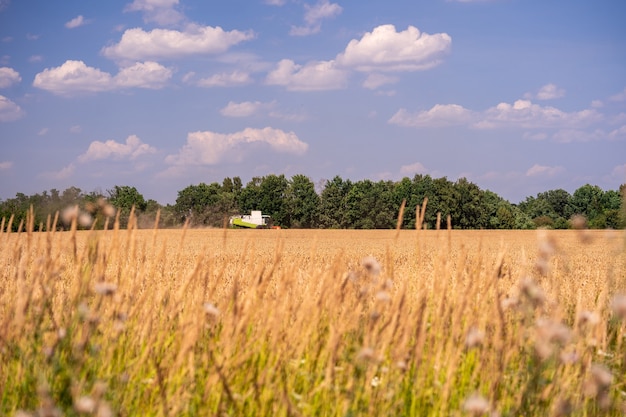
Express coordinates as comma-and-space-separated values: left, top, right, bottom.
0, 0, 626, 204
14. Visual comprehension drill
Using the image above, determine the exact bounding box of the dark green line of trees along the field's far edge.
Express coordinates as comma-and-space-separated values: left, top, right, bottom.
0, 174, 626, 231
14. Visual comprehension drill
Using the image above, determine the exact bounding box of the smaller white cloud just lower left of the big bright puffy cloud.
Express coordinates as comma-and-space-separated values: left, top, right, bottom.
266, 59, 348, 91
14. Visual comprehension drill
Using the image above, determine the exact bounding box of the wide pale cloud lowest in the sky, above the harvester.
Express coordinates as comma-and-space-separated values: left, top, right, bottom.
165, 127, 309, 166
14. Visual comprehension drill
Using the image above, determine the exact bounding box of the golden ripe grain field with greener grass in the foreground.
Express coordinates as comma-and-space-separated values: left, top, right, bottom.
0, 219, 626, 417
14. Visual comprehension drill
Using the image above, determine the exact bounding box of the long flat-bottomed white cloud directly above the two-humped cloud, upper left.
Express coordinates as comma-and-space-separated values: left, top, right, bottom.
102, 25, 254, 61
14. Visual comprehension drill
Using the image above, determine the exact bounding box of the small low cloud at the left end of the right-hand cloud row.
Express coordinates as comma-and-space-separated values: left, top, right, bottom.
389, 104, 474, 127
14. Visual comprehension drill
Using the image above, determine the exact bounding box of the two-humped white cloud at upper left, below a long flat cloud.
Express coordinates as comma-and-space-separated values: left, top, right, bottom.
33, 60, 172, 95
